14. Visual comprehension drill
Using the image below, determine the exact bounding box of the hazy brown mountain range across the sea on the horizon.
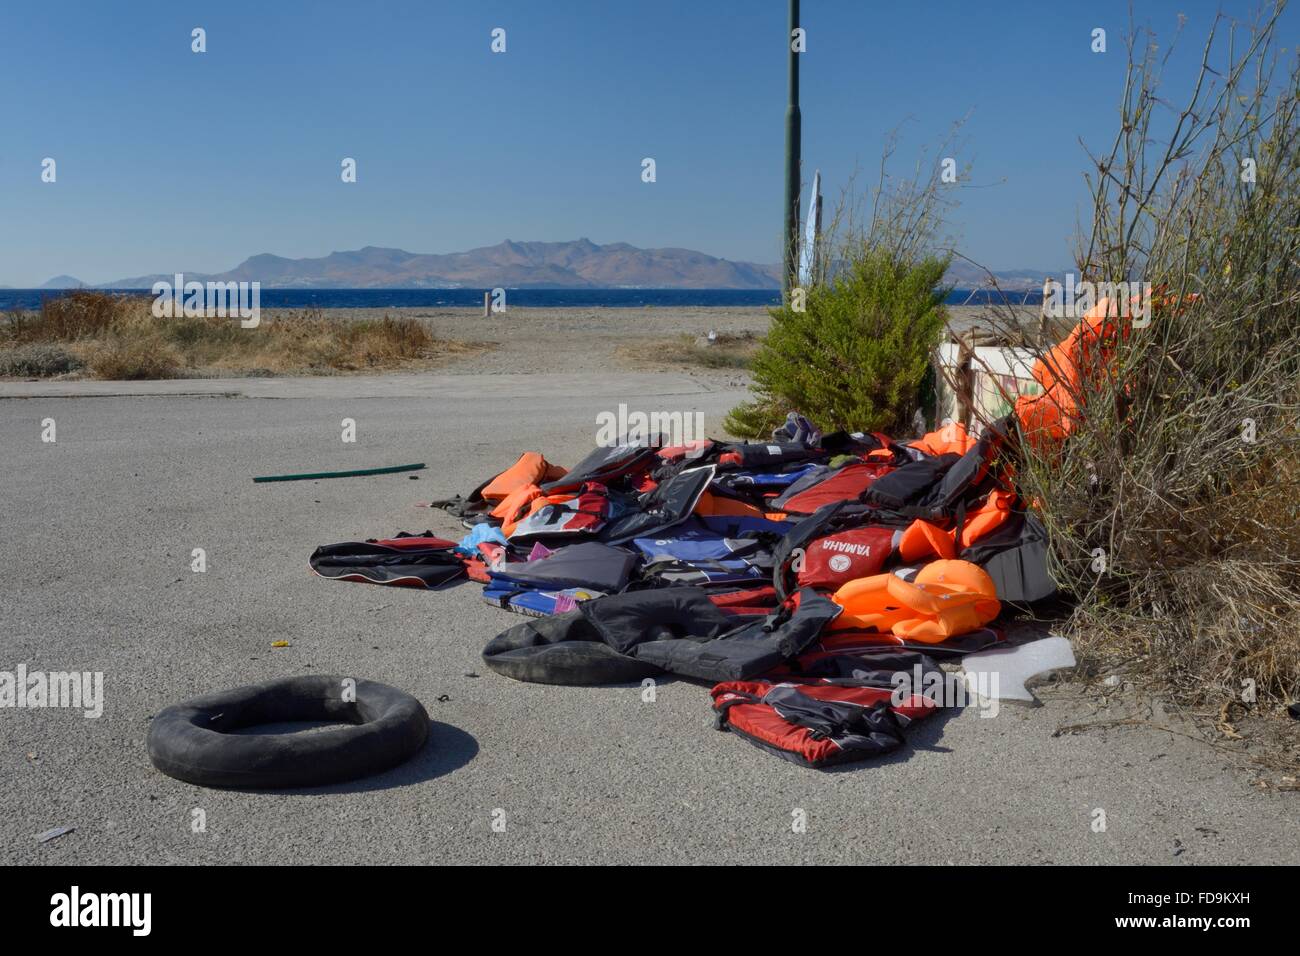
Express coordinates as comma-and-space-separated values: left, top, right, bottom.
42, 239, 1045, 290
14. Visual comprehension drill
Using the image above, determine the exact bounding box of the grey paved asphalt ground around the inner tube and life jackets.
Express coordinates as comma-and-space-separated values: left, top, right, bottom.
0, 372, 1300, 864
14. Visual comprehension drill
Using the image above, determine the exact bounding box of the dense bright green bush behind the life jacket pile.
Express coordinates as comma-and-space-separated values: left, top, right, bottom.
725, 248, 949, 438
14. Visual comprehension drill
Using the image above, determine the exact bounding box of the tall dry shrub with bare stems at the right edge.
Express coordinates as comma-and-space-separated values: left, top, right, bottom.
977, 10, 1300, 713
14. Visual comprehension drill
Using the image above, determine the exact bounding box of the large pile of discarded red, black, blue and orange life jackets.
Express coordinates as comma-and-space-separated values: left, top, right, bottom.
311, 414, 1054, 766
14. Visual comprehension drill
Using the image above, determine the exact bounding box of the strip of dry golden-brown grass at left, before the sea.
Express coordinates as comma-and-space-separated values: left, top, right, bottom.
0, 291, 488, 380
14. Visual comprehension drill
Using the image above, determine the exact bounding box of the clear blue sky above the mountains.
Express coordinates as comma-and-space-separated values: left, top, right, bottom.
0, 0, 1300, 286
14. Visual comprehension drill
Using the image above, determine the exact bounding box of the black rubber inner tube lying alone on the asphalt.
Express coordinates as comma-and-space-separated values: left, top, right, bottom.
148, 675, 429, 790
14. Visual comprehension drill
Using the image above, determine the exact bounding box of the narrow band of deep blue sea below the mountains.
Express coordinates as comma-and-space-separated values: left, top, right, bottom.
0, 289, 1043, 312
